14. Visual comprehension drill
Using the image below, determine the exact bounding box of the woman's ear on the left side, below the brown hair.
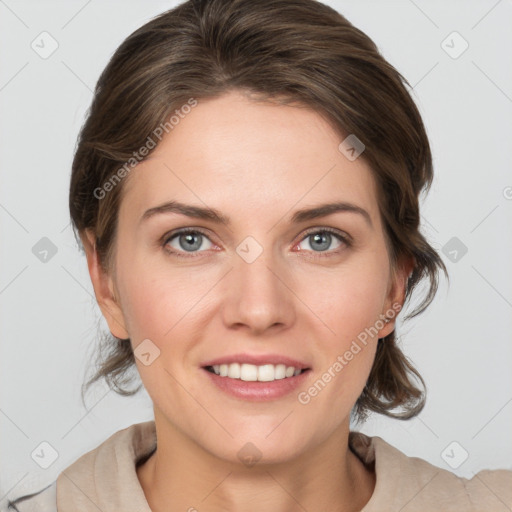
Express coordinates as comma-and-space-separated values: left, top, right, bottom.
80, 229, 130, 339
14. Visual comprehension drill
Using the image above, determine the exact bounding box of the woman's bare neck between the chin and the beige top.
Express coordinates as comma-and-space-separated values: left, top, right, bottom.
137, 417, 375, 512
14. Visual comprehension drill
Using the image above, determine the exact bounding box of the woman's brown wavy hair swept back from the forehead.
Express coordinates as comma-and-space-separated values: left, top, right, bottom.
69, 0, 447, 421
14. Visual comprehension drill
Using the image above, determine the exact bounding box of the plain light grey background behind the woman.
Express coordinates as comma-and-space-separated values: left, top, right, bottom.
0, 0, 512, 505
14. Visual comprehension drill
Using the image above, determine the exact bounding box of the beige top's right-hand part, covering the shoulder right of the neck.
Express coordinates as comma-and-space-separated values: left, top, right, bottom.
350, 432, 512, 512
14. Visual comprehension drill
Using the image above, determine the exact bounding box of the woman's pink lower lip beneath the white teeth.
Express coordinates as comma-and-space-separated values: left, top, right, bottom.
202, 368, 310, 402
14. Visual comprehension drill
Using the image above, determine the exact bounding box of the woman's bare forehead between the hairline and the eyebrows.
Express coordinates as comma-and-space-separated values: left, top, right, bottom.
121, 92, 377, 226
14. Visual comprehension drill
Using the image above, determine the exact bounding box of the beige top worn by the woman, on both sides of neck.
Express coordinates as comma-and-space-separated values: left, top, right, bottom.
12, 421, 512, 512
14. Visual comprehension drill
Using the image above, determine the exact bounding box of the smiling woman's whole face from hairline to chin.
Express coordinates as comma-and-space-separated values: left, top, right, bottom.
93, 92, 405, 462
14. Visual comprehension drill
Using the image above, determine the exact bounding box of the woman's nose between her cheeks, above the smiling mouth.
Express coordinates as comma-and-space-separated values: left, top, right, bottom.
222, 244, 297, 335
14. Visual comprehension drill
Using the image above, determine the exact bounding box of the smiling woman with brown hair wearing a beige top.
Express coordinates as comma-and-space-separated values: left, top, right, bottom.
12, 0, 512, 512
